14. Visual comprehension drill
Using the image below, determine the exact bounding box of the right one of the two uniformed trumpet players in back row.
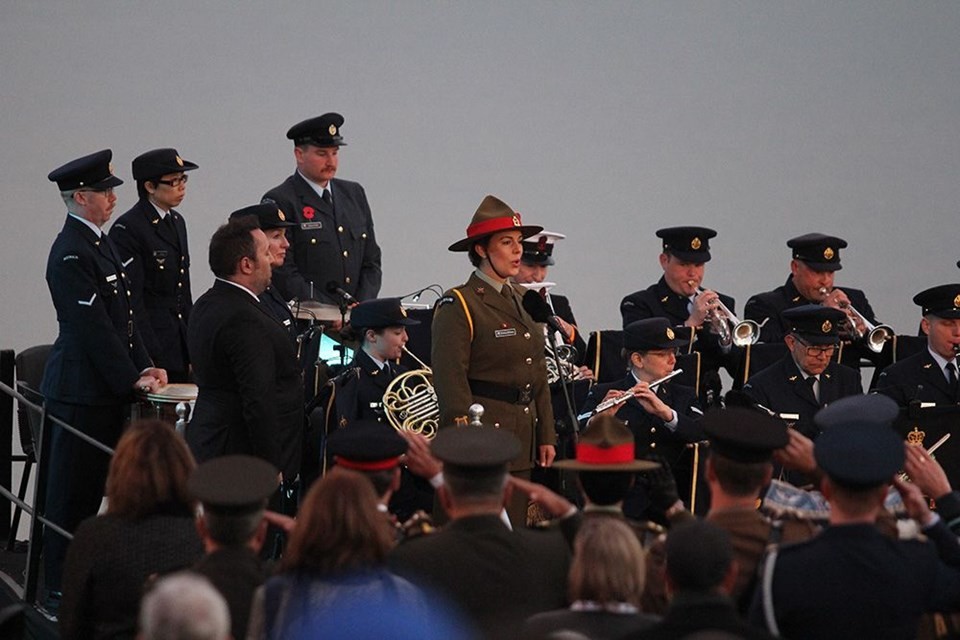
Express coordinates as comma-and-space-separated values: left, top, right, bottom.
743, 233, 877, 348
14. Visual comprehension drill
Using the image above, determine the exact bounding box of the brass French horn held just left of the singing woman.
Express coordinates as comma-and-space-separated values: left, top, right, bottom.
383, 347, 440, 439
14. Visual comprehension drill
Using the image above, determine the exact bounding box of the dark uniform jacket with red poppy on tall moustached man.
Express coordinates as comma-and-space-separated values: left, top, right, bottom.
262, 173, 382, 304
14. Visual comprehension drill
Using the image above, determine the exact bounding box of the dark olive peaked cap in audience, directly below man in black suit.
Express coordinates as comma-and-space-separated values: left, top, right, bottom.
187, 455, 280, 515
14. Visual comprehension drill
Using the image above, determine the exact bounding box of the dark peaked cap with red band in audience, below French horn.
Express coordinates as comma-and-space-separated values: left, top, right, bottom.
327, 420, 407, 471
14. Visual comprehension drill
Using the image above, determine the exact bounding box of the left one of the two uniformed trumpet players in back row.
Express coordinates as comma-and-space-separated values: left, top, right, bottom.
620, 226, 734, 397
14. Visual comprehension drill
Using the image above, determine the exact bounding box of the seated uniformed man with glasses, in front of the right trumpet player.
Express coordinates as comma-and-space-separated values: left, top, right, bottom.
743, 304, 863, 440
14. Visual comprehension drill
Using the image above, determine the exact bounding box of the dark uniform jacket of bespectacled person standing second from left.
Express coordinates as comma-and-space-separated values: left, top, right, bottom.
110, 199, 193, 372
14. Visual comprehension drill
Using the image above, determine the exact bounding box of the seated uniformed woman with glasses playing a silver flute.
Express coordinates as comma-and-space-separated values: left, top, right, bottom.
579, 318, 705, 523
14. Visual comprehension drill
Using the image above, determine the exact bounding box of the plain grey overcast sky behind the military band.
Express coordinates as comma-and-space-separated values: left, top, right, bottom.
0, 0, 960, 358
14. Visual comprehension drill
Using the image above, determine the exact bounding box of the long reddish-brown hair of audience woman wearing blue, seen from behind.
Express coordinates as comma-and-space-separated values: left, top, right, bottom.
280, 468, 393, 575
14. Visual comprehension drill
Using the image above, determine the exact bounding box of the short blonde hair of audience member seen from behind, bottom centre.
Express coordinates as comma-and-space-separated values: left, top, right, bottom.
569, 518, 646, 608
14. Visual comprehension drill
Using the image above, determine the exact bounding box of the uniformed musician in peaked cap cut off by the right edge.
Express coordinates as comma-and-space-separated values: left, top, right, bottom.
876, 284, 960, 407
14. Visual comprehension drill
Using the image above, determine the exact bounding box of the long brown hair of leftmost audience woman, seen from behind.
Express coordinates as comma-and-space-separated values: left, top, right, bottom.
106, 420, 195, 518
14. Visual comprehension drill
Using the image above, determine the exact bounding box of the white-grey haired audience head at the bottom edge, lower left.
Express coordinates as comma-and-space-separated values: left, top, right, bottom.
138, 572, 231, 640
